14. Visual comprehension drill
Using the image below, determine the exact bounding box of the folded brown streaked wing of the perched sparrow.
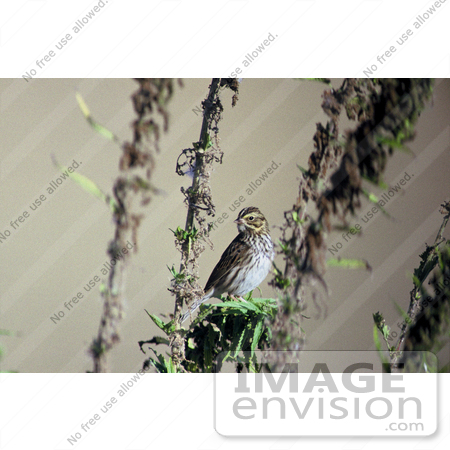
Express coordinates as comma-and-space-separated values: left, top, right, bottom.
205, 233, 250, 292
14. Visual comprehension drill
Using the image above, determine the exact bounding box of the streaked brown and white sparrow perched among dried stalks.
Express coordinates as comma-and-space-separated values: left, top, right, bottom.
181, 206, 275, 322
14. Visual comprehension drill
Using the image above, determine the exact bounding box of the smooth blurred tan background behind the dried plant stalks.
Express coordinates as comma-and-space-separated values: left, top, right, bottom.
0, 79, 450, 372
